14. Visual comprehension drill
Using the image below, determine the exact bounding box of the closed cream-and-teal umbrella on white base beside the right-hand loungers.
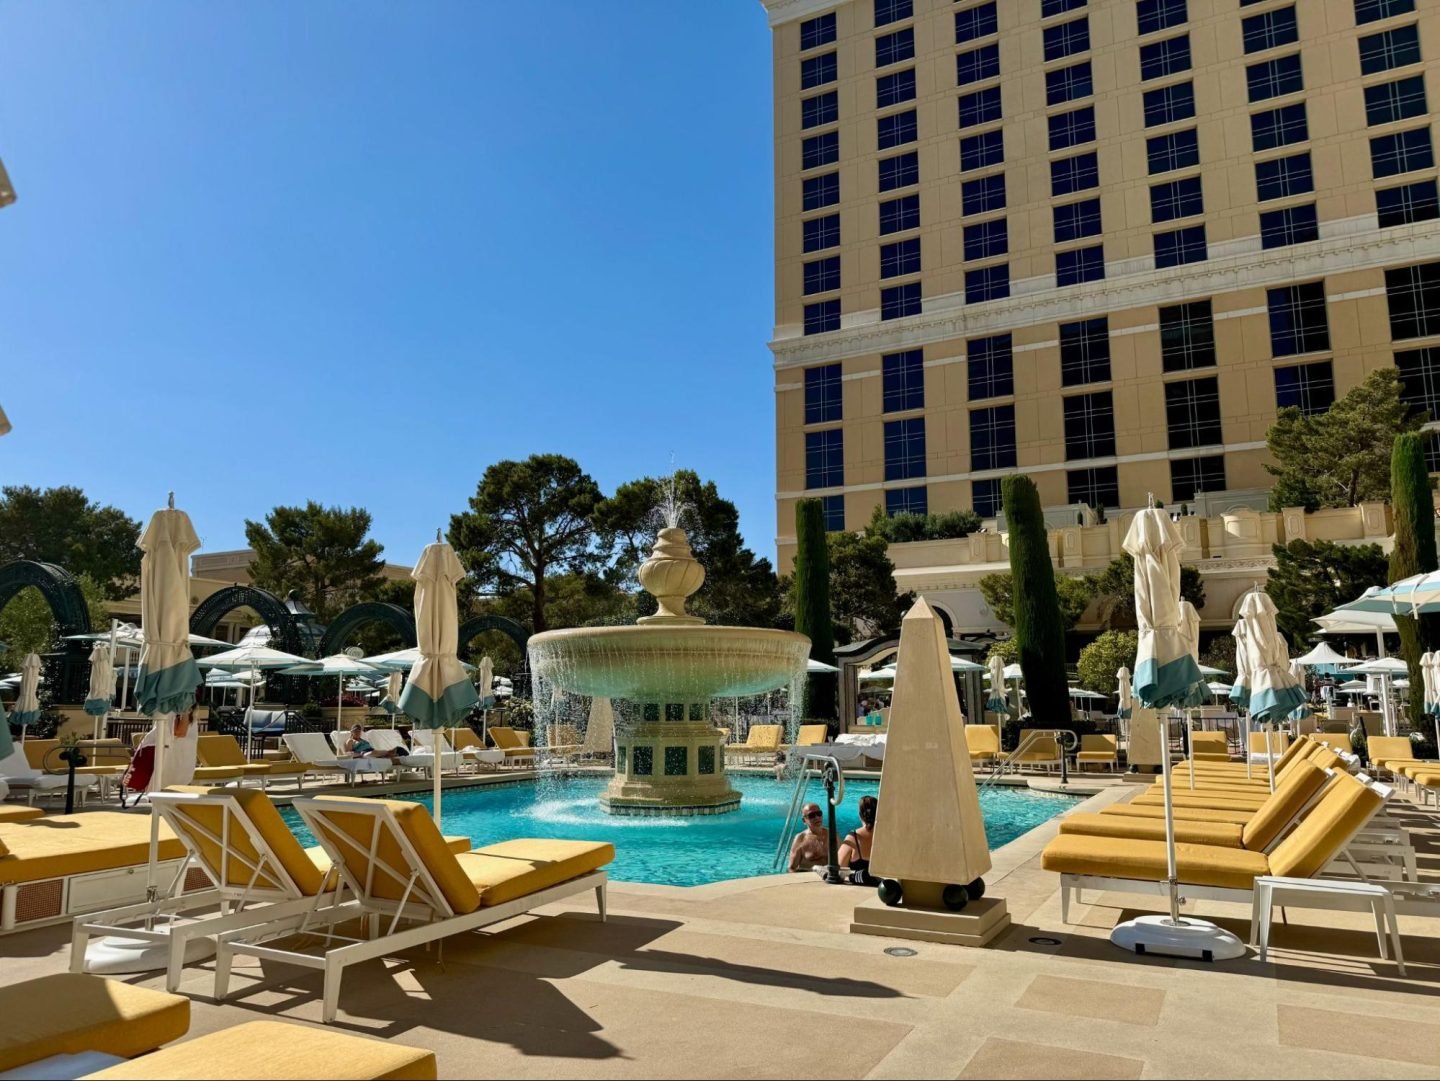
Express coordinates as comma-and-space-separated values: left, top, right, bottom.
1110, 501, 1246, 960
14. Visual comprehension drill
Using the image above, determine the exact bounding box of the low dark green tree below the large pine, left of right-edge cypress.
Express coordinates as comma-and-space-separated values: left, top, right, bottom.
1267, 540, 1390, 650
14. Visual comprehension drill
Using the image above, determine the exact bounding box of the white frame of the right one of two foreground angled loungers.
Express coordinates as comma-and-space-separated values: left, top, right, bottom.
215, 799, 608, 1025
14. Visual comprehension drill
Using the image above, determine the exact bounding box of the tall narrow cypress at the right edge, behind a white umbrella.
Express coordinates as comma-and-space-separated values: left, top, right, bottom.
1390, 432, 1440, 731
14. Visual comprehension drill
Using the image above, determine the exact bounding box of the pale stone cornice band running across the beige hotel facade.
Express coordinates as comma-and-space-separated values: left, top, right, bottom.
770, 222, 1440, 368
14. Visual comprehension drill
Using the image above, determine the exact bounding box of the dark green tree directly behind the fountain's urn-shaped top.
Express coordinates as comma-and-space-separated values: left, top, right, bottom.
593, 469, 780, 626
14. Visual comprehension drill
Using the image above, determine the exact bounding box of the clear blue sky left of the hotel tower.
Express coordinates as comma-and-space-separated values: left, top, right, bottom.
0, 0, 775, 563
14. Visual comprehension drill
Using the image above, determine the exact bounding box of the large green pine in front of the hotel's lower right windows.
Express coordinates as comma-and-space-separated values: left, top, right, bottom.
1266, 367, 1427, 511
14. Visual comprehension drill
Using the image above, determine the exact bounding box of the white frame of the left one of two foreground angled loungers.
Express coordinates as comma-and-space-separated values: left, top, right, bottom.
71, 792, 357, 992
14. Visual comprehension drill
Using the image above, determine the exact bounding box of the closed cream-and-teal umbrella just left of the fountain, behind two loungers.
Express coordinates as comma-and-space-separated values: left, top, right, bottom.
400, 530, 480, 828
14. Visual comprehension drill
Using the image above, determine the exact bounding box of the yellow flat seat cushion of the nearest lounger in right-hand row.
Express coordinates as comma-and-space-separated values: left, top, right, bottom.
1040, 833, 1270, 890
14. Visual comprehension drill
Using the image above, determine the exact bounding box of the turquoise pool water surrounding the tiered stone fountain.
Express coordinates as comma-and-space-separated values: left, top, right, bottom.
282, 776, 1076, 885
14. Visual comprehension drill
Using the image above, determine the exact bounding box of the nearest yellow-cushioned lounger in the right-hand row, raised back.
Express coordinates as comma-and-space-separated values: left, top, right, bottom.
1041, 774, 1391, 923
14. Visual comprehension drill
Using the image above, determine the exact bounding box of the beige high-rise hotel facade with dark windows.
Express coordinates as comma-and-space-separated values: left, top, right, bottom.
762, 0, 1440, 567
